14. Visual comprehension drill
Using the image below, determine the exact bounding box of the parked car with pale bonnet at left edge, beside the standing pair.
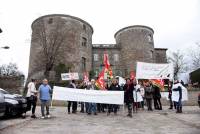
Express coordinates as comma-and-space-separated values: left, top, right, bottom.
0, 88, 27, 116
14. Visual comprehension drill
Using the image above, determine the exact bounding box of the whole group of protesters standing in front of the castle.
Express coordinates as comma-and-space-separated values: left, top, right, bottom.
26, 78, 185, 119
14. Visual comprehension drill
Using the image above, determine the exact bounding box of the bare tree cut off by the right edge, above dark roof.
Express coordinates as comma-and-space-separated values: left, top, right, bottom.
190, 42, 200, 70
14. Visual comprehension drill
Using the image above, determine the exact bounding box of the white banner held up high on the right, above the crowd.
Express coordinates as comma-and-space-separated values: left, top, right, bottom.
136, 62, 173, 79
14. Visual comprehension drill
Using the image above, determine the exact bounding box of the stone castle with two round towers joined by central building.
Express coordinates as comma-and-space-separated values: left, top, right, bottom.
28, 14, 167, 79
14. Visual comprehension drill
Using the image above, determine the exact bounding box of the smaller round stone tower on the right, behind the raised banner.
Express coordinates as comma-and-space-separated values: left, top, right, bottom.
115, 25, 154, 76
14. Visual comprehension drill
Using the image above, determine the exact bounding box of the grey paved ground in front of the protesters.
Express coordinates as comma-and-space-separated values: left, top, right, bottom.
0, 107, 200, 134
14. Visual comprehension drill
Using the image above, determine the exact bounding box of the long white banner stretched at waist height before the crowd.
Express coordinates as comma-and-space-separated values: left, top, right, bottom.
52, 86, 124, 105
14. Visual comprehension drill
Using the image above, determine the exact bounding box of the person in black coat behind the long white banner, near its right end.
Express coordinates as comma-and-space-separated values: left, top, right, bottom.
107, 79, 120, 115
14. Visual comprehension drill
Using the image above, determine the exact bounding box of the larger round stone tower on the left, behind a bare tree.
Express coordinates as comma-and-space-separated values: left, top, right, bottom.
28, 14, 93, 78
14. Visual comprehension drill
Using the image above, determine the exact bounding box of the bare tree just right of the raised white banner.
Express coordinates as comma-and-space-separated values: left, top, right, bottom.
168, 50, 187, 79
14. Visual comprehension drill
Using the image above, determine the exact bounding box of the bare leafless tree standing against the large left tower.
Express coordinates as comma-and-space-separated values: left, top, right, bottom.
34, 19, 67, 78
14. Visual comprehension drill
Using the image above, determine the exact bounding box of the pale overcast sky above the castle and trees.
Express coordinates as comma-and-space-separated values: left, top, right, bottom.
0, 0, 200, 75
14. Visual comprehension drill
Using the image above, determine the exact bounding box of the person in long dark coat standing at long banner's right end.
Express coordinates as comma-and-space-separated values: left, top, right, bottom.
123, 79, 134, 117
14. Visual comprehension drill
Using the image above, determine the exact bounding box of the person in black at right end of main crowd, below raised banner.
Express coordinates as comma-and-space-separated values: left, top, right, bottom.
153, 86, 162, 110
